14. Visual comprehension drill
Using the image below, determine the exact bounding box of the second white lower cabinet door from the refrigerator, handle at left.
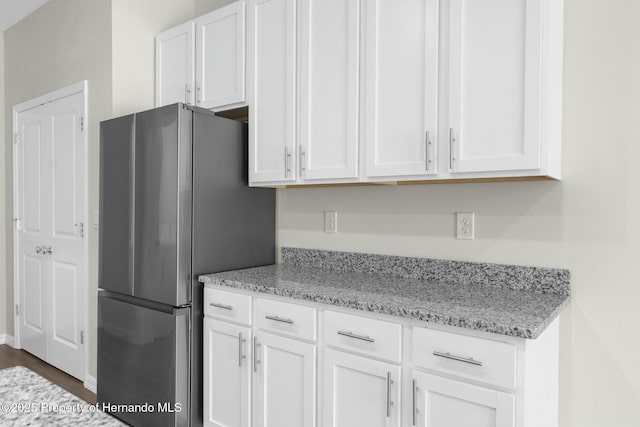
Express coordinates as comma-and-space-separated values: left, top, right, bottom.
253, 332, 316, 427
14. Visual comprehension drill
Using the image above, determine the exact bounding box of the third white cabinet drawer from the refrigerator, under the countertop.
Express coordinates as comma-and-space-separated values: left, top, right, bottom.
323, 311, 402, 363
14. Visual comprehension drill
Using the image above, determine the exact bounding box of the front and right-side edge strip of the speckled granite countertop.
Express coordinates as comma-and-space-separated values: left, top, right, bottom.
199, 275, 570, 339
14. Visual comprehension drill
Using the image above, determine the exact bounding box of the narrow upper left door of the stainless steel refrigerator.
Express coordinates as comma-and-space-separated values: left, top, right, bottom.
98, 114, 135, 295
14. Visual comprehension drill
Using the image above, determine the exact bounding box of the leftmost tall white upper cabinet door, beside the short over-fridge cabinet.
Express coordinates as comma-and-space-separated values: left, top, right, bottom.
247, 0, 296, 184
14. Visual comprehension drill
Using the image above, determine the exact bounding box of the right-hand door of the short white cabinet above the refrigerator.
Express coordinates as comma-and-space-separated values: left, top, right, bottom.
195, 1, 245, 108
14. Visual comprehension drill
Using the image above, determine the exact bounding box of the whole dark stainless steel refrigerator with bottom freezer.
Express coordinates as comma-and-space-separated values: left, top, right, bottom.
97, 104, 275, 426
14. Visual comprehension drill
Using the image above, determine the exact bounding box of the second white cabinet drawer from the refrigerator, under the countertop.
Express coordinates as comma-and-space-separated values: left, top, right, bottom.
256, 298, 317, 341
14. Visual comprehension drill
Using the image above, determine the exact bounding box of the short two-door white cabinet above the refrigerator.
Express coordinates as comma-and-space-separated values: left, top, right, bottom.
156, 1, 246, 110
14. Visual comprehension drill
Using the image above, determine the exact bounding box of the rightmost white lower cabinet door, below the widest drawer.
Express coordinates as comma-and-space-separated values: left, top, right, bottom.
407, 371, 515, 427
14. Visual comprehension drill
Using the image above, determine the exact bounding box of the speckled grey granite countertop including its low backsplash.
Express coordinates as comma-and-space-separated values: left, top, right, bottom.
199, 248, 569, 338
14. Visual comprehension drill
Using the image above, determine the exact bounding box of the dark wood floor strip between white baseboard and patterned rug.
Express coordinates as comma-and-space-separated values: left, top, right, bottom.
0, 344, 96, 405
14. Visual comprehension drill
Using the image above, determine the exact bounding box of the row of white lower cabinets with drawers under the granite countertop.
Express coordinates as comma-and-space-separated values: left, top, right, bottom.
203, 287, 559, 427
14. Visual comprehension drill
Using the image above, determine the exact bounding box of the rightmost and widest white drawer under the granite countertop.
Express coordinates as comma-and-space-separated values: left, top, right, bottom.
413, 328, 516, 389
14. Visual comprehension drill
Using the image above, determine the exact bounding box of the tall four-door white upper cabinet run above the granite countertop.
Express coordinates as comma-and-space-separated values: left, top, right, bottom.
247, 0, 563, 186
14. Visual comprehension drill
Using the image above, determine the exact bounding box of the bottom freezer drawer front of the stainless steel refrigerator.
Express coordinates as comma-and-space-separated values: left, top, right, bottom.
98, 292, 190, 426
